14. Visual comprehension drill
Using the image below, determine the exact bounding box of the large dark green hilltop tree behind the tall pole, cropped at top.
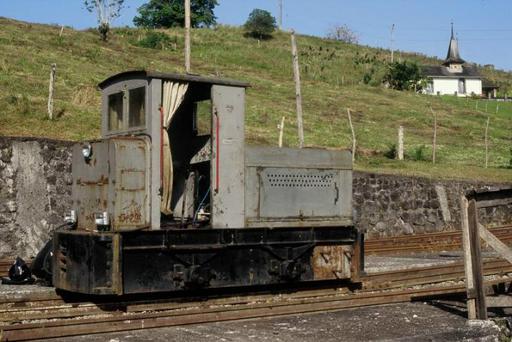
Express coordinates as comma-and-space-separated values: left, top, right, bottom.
133, 0, 218, 28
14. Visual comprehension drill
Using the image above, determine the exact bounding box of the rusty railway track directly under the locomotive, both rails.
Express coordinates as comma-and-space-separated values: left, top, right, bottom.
0, 260, 512, 341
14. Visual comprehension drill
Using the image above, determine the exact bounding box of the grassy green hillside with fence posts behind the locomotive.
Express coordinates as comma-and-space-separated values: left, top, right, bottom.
0, 18, 512, 181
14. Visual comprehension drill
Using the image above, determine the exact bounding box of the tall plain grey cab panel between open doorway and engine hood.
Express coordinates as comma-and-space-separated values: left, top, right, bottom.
211, 85, 245, 228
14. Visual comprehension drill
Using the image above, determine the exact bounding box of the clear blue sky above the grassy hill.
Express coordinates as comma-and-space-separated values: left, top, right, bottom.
0, 0, 512, 71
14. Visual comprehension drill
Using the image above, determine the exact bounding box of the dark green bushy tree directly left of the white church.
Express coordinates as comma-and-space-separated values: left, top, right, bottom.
384, 61, 422, 91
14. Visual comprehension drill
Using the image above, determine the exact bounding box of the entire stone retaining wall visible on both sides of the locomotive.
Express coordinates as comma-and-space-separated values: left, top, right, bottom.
0, 137, 512, 258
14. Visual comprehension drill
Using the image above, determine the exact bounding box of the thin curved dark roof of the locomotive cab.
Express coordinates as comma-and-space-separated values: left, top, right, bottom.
98, 70, 250, 89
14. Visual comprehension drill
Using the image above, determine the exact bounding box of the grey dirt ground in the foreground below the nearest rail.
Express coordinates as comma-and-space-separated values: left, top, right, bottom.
37, 302, 512, 342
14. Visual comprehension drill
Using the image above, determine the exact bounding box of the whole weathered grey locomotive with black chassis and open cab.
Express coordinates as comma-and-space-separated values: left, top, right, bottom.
45, 71, 363, 295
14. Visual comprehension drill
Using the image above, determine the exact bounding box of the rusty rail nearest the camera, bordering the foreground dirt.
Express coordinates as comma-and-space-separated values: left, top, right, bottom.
1, 285, 486, 341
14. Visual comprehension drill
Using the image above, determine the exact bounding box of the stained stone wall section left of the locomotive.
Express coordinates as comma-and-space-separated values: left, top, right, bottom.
0, 137, 72, 258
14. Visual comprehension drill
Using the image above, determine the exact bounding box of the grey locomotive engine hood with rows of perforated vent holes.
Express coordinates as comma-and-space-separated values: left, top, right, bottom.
245, 147, 353, 227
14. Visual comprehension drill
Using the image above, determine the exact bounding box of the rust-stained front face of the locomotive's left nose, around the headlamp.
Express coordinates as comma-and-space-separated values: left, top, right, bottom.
72, 141, 109, 230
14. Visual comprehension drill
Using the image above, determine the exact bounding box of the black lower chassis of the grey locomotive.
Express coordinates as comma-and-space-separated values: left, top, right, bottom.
54, 227, 363, 295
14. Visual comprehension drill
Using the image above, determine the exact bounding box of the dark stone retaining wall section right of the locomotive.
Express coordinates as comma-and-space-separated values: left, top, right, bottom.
353, 172, 512, 238
